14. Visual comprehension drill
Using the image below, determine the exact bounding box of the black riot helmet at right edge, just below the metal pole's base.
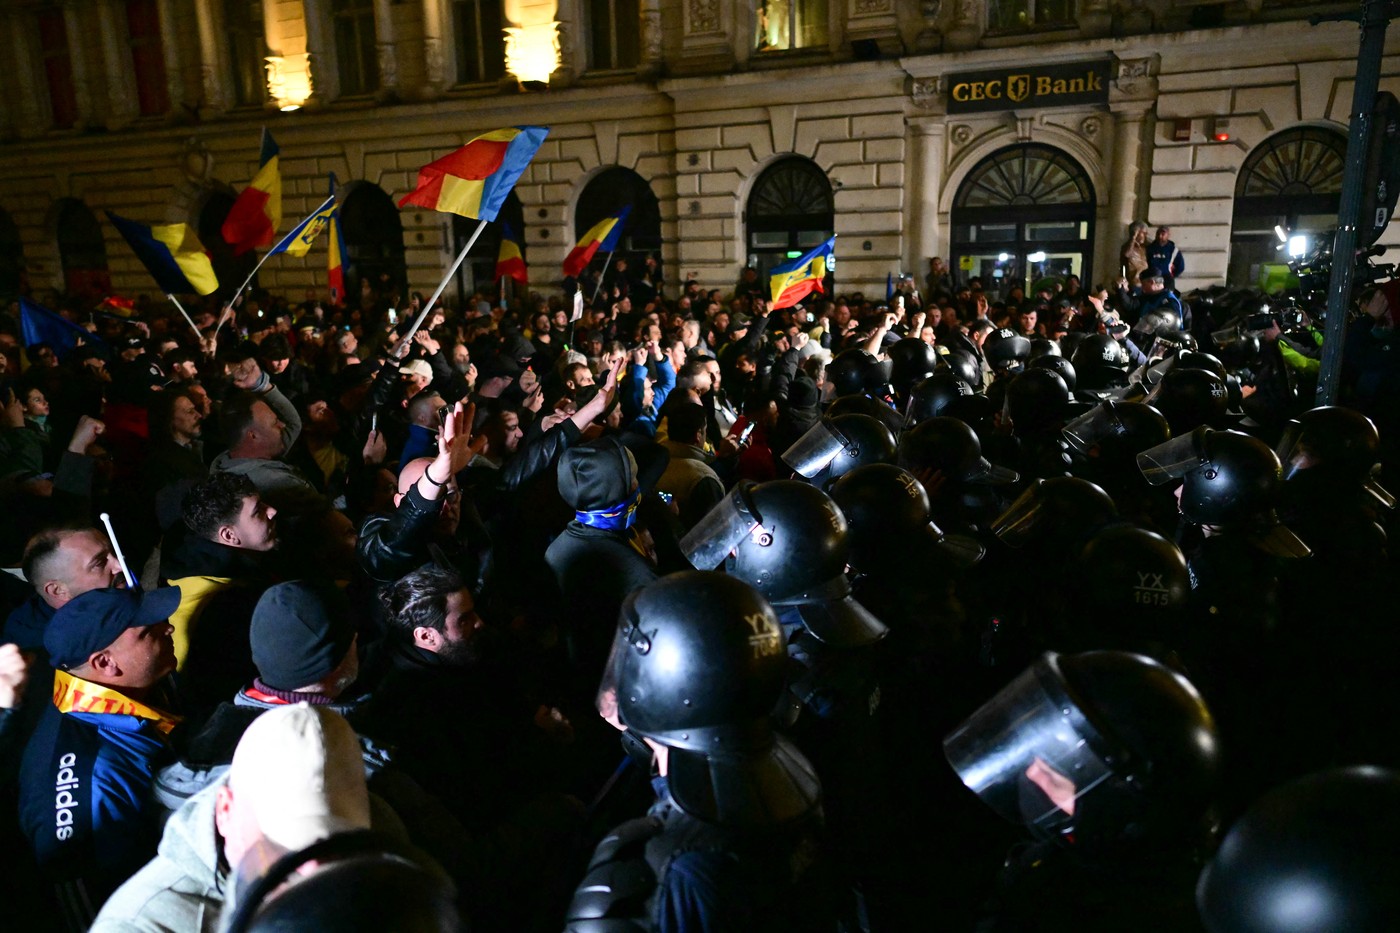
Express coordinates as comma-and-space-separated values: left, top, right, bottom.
1274, 405, 1396, 509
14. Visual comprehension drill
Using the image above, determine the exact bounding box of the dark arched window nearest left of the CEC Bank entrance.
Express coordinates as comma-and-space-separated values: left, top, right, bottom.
743, 157, 836, 282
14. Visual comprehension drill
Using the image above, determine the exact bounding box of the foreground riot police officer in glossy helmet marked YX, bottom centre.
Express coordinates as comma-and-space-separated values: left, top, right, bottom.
567, 572, 826, 933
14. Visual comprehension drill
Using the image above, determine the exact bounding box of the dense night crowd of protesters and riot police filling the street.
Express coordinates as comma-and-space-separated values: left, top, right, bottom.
0, 254, 1400, 932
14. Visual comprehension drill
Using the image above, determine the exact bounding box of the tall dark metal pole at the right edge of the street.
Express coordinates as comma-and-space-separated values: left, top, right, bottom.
1317, 0, 1390, 405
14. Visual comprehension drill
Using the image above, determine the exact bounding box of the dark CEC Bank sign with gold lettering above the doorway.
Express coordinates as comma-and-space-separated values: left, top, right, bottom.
948, 59, 1109, 113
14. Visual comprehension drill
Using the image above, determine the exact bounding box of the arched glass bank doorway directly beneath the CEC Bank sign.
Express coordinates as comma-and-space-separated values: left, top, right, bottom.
951, 143, 1095, 297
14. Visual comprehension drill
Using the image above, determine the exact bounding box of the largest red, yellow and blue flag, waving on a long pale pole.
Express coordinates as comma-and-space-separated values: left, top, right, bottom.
399, 126, 549, 220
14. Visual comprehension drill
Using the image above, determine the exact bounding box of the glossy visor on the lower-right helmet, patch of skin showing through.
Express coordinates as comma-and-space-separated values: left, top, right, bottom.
944, 651, 1119, 829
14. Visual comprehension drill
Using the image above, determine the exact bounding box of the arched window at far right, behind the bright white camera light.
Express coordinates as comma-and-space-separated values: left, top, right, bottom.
1226, 126, 1347, 286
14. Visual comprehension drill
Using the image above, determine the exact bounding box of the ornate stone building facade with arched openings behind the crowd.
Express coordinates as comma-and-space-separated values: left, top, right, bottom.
0, 0, 1400, 298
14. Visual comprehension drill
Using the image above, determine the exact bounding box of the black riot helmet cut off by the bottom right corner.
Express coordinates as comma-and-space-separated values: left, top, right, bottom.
1196, 766, 1400, 933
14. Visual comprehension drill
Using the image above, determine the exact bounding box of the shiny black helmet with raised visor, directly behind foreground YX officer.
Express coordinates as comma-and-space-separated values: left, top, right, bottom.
680, 479, 886, 647
